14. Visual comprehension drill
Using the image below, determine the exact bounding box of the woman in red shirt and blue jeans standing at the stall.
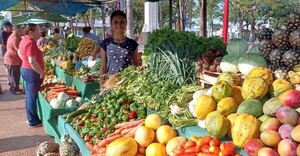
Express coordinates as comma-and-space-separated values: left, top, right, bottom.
19, 24, 44, 127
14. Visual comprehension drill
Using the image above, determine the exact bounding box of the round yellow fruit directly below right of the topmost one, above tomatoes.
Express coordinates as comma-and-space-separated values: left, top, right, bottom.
156, 125, 177, 145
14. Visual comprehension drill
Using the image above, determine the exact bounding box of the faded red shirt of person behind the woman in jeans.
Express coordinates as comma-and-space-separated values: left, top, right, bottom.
4, 32, 22, 65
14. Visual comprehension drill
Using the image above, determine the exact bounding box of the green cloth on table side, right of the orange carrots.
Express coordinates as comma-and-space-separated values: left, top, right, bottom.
72, 78, 100, 99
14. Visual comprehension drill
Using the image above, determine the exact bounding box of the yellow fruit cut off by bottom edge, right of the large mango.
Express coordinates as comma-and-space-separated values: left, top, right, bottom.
146, 143, 167, 156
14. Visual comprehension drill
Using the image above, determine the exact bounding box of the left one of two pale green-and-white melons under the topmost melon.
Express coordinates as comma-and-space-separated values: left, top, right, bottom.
220, 55, 239, 73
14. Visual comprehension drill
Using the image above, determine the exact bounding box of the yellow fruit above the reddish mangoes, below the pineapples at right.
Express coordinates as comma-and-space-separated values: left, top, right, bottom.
270, 79, 293, 96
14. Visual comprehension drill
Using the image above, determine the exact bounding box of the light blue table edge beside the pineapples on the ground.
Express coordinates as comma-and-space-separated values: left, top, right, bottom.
58, 115, 90, 156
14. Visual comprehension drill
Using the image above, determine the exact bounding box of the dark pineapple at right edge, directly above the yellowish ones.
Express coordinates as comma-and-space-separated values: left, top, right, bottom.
282, 49, 300, 68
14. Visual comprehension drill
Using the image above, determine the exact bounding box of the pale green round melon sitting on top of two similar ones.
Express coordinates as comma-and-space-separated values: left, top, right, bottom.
227, 39, 249, 57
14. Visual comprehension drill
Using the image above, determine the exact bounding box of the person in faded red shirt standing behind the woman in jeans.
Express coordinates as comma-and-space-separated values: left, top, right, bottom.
4, 25, 23, 95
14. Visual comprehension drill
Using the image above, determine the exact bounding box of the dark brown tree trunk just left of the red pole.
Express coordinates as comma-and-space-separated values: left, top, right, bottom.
199, 0, 207, 37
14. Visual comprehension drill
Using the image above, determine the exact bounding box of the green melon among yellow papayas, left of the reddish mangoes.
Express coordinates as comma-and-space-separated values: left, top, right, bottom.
237, 99, 263, 117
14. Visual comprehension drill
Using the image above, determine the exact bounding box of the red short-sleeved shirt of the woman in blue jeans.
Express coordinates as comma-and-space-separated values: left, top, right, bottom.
19, 36, 44, 69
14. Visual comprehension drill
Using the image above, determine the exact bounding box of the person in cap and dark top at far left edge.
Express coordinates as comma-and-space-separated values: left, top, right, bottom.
0, 21, 12, 57
